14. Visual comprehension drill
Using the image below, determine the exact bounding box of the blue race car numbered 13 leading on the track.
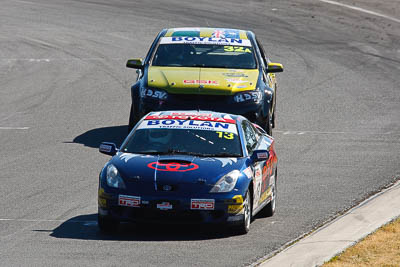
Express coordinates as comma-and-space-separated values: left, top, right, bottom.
98, 111, 277, 234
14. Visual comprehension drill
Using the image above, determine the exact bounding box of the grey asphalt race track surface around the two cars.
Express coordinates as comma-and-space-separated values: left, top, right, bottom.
0, 0, 400, 266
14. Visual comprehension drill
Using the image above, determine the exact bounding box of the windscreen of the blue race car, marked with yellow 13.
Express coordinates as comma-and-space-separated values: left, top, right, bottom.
121, 120, 242, 157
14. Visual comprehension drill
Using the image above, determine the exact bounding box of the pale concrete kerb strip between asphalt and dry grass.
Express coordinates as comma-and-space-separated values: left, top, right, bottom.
256, 181, 400, 267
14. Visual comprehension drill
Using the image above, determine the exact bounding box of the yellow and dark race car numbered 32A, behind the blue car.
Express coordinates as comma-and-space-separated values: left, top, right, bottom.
126, 28, 283, 135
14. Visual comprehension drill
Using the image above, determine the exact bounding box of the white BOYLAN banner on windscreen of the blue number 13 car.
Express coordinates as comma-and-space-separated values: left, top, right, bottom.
138, 118, 237, 135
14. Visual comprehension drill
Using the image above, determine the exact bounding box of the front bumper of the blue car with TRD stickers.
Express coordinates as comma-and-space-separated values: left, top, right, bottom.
98, 189, 243, 224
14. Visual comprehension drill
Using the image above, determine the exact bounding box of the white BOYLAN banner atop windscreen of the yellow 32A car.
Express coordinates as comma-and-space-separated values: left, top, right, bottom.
160, 36, 251, 47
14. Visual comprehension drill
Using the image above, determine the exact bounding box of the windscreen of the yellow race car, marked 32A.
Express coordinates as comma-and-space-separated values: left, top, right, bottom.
152, 37, 257, 69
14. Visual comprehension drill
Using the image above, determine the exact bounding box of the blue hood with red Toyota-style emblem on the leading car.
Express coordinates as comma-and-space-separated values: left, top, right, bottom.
111, 153, 245, 185
